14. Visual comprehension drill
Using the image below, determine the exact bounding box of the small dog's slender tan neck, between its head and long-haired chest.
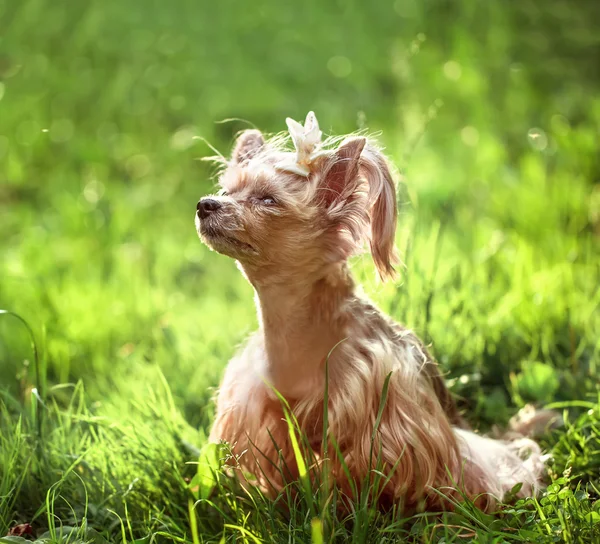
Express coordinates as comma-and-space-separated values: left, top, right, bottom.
254, 264, 354, 399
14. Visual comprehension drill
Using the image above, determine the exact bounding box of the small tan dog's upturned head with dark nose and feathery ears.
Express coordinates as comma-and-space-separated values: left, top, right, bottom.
196, 115, 397, 281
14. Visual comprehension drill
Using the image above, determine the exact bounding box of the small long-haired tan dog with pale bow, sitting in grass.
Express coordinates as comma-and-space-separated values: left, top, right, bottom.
196, 112, 544, 510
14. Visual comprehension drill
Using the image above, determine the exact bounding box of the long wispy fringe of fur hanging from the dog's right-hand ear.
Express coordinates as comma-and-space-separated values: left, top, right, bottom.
360, 143, 399, 280
